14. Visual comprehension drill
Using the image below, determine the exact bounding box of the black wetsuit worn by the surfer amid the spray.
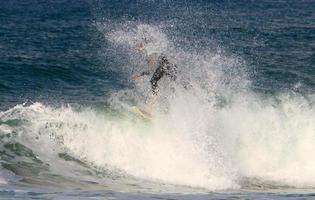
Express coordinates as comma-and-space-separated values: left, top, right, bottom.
141, 55, 177, 95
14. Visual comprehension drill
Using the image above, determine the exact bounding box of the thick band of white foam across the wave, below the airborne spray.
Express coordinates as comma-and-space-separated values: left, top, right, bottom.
1, 90, 315, 190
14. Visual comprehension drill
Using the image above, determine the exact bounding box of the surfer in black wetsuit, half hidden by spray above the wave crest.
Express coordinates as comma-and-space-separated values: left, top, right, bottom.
131, 43, 177, 96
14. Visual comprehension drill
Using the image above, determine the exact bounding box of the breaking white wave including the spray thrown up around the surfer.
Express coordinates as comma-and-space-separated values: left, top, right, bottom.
0, 24, 315, 190
